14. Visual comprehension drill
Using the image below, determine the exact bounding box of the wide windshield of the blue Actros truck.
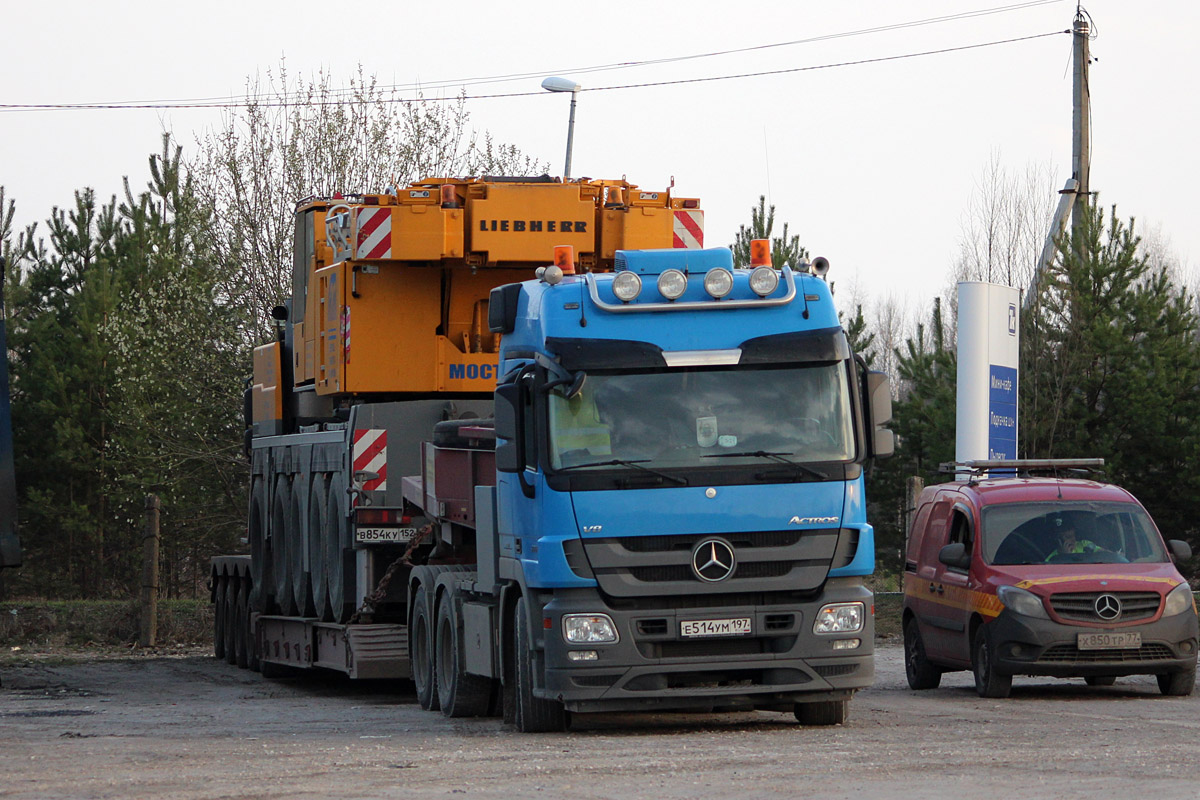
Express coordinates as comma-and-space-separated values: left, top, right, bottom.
550, 363, 854, 470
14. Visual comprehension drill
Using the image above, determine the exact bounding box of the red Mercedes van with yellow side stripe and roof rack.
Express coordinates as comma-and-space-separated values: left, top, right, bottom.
904, 459, 1196, 697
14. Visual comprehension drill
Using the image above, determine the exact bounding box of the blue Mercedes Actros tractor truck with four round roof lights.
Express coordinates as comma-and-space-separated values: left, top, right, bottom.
404, 242, 893, 730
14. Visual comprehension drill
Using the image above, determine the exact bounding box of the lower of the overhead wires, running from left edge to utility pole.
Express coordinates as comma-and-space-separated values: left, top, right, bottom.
0, 29, 1070, 112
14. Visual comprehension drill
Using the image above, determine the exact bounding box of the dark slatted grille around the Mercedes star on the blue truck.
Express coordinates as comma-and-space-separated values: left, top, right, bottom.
583, 528, 857, 599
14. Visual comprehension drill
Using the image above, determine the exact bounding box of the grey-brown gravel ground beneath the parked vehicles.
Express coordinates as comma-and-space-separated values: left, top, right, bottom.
0, 643, 1200, 800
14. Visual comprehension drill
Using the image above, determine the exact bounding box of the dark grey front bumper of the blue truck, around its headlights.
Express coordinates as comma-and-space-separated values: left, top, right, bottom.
535, 578, 875, 711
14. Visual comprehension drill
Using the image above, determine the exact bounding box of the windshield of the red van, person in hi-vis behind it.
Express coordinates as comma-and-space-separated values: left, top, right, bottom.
983, 501, 1168, 565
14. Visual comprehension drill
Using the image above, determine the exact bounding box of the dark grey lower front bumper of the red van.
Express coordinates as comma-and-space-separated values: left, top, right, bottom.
988, 610, 1196, 678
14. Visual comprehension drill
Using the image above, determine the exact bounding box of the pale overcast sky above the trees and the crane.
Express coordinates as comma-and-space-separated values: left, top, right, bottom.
0, 0, 1200, 319
